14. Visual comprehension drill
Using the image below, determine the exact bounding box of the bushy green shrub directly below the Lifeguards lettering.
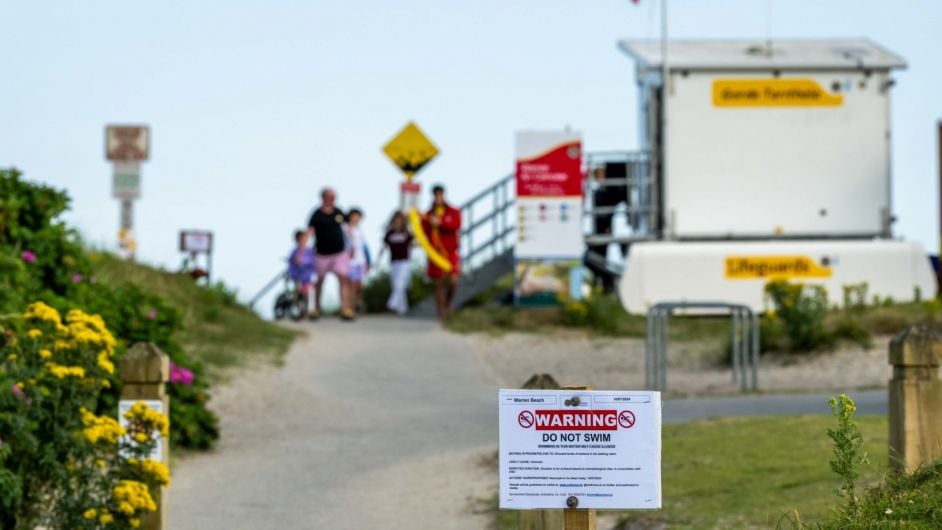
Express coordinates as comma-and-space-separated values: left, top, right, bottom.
765, 280, 834, 351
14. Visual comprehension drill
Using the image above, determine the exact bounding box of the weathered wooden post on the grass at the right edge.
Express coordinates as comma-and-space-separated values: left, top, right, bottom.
889, 324, 942, 471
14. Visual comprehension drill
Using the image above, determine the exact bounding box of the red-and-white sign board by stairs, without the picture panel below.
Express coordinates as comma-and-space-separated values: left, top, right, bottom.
514, 131, 585, 259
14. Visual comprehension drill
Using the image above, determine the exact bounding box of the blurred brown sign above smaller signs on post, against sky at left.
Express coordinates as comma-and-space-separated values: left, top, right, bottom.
105, 125, 150, 260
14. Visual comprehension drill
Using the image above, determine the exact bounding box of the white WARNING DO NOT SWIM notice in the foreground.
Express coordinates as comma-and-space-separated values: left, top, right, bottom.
498, 390, 661, 510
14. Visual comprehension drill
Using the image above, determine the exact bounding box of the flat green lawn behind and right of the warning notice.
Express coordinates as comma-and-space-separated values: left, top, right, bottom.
494, 415, 888, 530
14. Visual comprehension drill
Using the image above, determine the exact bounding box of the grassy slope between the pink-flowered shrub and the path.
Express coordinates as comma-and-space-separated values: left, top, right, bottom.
92, 254, 295, 380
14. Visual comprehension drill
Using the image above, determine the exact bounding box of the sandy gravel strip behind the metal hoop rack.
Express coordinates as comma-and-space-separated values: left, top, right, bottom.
464, 330, 892, 397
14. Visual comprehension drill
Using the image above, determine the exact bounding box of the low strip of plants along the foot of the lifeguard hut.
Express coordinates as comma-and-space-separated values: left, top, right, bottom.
446, 281, 942, 357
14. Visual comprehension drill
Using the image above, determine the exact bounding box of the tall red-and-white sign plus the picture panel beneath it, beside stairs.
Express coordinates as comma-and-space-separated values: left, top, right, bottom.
514, 131, 585, 303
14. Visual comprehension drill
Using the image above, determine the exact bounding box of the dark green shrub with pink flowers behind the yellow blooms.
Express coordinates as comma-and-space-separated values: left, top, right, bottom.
0, 169, 218, 449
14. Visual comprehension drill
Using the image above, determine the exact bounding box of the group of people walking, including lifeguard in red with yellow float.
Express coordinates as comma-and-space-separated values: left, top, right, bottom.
288, 185, 461, 321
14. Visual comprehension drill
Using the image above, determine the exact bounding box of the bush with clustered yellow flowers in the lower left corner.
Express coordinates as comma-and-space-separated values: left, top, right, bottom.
0, 302, 170, 530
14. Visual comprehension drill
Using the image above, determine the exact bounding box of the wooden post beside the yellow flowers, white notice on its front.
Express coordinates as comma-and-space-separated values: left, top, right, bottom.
118, 342, 170, 530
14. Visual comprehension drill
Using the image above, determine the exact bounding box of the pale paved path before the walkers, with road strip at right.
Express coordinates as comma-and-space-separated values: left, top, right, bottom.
169, 318, 886, 530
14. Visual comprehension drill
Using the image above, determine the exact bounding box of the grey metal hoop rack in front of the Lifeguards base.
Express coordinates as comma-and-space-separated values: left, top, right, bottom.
644, 302, 759, 392
